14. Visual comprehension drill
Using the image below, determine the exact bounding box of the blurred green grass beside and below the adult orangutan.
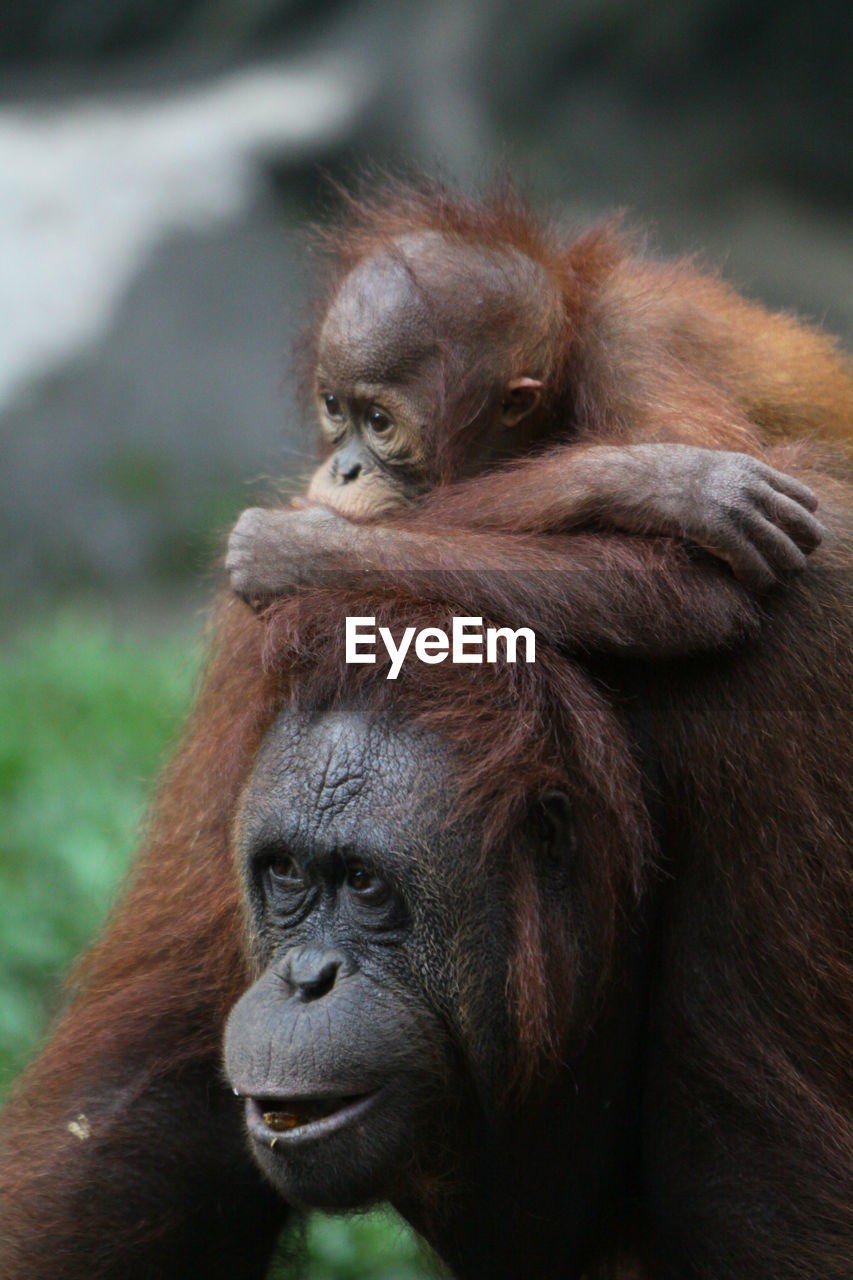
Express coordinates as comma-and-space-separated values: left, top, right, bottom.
0, 611, 435, 1280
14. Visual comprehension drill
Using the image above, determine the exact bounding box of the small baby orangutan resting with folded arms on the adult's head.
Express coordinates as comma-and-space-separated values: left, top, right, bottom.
227, 187, 853, 627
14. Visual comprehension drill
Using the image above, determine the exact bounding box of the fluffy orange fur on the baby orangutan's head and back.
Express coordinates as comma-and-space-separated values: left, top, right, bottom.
307, 180, 853, 483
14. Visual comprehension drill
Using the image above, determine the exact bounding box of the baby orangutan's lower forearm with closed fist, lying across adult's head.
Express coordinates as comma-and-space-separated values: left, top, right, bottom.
228, 507, 760, 658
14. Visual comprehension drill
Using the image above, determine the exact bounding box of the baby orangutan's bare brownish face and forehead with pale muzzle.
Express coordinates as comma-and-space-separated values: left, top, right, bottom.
307, 232, 543, 520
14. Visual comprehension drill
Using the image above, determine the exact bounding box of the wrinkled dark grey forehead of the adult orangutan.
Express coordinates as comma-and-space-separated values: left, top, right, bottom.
243, 712, 452, 845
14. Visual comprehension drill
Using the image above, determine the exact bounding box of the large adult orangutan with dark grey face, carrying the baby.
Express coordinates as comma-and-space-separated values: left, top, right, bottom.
0, 437, 853, 1280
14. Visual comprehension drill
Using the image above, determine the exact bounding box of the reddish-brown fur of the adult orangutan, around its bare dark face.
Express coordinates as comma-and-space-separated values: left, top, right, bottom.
0, 468, 853, 1280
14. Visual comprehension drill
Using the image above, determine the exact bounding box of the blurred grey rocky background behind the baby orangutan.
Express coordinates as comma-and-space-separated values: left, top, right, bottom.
0, 0, 853, 618
